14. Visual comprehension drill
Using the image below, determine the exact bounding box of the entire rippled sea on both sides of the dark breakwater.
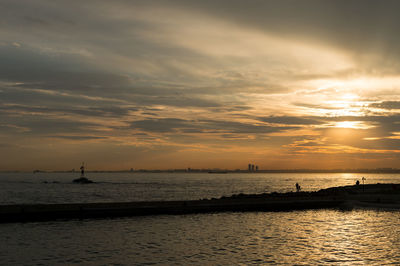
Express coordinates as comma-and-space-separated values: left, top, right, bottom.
0, 172, 400, 265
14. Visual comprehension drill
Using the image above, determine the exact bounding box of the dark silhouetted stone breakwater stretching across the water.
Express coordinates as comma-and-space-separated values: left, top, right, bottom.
0, 184, 400, 223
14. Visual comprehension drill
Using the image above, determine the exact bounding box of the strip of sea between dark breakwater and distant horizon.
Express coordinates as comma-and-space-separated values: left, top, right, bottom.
0, 173, 400, 204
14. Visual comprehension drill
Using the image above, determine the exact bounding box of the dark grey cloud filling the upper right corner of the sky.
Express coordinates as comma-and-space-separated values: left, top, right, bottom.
167, 0, 400, 61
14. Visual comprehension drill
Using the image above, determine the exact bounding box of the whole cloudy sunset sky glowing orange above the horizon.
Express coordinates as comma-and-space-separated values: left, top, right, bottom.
0, 0, 400, 171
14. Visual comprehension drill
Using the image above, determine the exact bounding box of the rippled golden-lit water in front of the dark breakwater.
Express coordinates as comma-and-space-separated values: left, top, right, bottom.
0, 210, 400, 265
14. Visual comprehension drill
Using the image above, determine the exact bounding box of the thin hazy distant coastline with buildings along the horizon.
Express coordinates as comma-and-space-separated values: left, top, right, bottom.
0, 168, 400, 174
